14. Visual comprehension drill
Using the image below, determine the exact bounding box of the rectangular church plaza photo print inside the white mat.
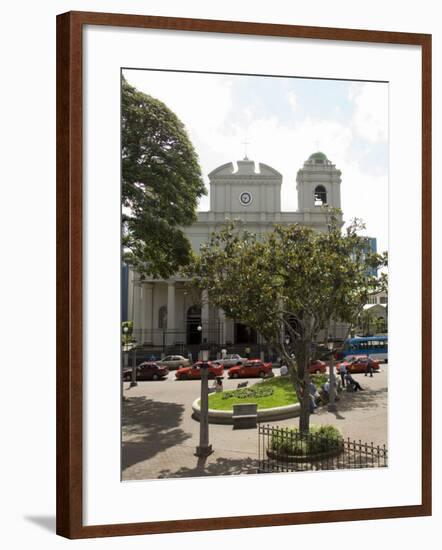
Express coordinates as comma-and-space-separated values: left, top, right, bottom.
121, 68, 386, 481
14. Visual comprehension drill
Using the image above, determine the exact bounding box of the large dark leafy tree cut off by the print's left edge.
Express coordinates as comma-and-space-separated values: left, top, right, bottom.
121, 79, 206, 278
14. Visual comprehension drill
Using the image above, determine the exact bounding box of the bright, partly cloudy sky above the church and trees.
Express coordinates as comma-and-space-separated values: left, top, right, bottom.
123, 69, 388, 252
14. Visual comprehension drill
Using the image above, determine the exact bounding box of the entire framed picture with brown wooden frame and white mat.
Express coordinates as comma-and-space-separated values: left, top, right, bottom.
57, 12, 431, 538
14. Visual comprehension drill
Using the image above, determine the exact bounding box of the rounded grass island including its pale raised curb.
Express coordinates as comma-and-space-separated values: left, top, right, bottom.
192, 375, 326, 424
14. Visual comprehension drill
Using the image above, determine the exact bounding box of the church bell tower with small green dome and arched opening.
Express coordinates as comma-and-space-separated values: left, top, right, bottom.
296, 151, 341, 212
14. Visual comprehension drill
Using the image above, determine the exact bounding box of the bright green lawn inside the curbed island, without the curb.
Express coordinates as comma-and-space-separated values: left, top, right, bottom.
209, 375, 325, 411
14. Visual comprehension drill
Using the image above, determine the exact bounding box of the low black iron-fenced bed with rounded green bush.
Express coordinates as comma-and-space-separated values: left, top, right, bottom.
258, 424, 388, 473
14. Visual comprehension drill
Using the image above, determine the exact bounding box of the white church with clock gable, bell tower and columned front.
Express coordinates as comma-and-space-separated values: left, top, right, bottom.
128, 152, 344, 354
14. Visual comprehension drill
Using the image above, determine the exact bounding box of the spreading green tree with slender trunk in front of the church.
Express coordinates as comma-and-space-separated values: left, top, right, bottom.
192, 210, 383, 433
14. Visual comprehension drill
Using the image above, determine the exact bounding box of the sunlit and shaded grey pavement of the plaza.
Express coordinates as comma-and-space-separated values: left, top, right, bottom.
122, 365, 388, 480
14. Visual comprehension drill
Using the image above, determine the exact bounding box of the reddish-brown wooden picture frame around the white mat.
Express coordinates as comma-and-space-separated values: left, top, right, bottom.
57, 12, 431, 538
